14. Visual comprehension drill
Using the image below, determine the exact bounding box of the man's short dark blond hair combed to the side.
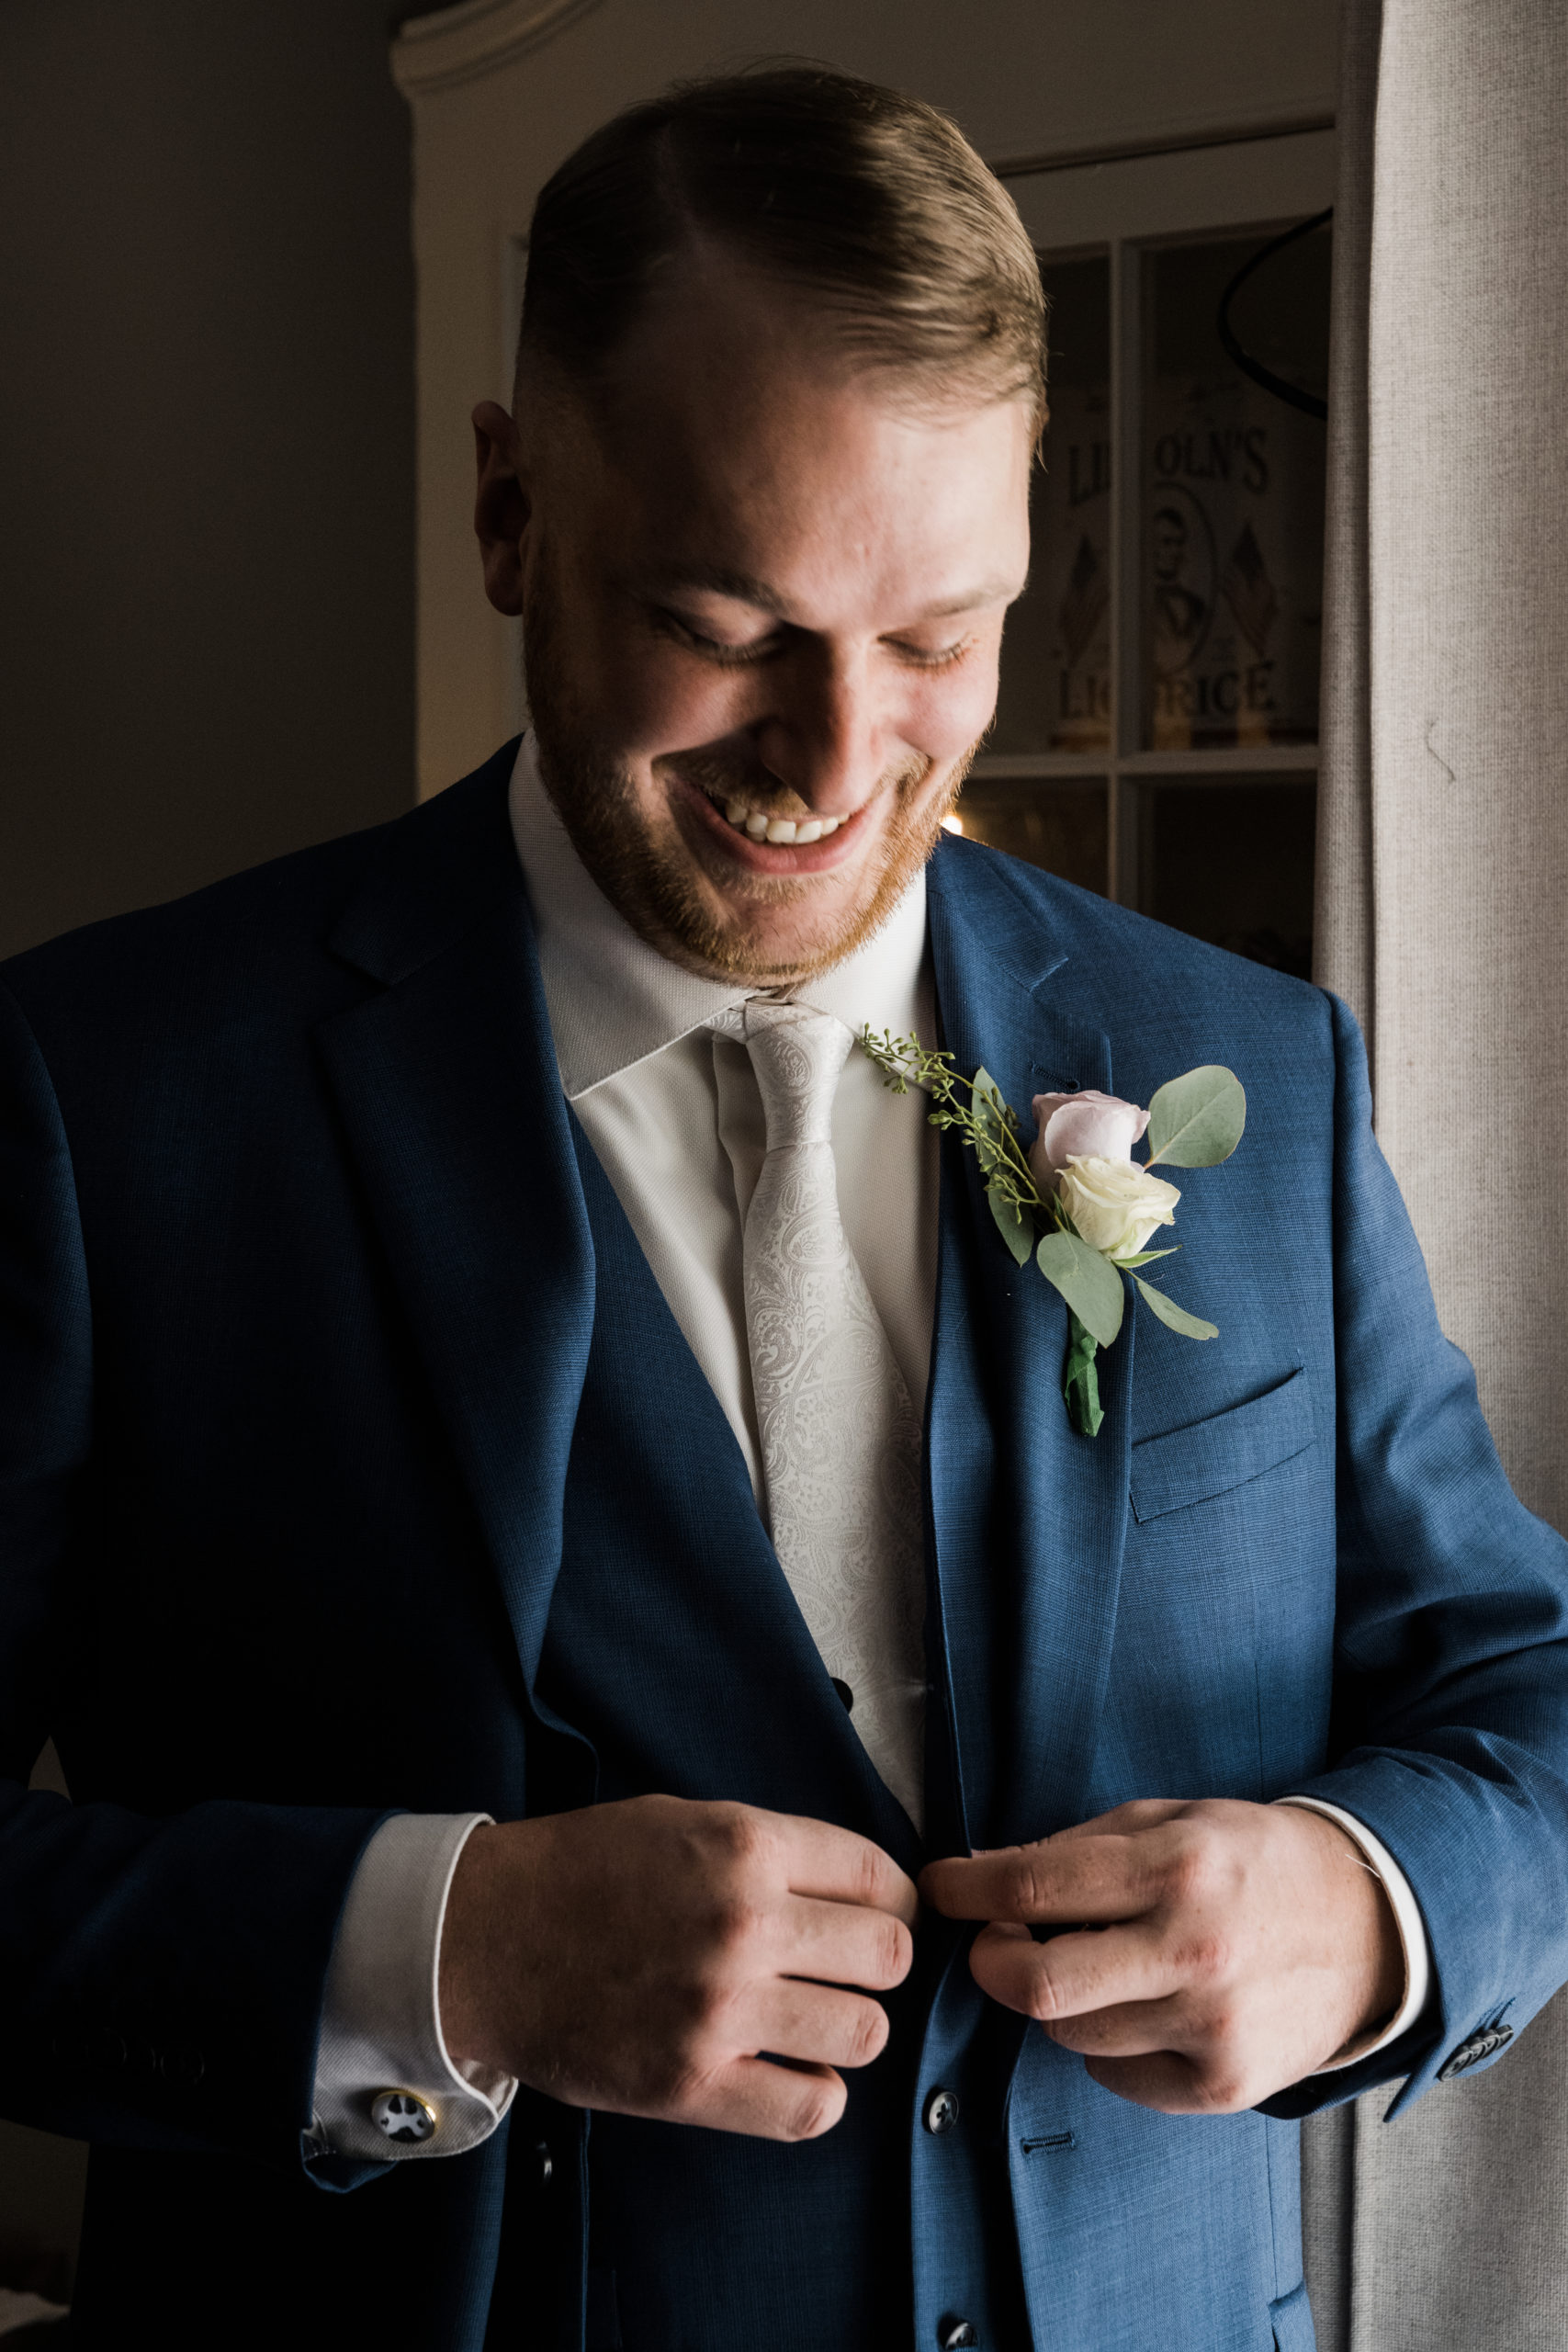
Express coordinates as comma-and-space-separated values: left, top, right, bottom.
517, 63, 1046, 424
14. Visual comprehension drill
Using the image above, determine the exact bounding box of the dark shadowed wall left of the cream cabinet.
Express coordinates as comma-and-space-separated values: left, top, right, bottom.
0, 0, 419, 955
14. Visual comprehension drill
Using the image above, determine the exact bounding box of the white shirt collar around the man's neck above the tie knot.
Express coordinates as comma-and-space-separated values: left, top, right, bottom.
508, 736, 926, 1101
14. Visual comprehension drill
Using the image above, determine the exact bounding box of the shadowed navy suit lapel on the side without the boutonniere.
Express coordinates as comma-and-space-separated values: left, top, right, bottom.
320, 746, 592, 1687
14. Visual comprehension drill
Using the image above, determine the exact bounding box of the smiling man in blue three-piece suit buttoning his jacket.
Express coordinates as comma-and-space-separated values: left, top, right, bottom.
0, 71, 1568, 2352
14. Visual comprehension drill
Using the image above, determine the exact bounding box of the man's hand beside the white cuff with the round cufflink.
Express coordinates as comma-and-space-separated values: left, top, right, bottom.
440, 1797, 917, 2141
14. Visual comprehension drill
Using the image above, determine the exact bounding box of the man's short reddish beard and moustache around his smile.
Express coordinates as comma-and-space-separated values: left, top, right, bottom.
522, 573, 978, 988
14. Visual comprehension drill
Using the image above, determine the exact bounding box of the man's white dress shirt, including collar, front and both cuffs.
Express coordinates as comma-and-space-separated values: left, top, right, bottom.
315, 739, 1429, 2159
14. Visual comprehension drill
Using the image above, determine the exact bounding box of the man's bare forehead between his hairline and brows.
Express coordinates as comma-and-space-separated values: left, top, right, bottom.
559, 266, 1034, 605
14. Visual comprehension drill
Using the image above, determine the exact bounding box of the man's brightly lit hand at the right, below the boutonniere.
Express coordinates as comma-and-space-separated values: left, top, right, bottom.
919, 1799, 1404, 2114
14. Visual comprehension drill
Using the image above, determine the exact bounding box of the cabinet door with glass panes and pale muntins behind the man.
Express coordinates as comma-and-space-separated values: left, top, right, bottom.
957, 131, 1333, 974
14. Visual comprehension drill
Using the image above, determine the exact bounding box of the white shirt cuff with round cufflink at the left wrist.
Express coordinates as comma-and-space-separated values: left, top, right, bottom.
308, 1814, 517, 2164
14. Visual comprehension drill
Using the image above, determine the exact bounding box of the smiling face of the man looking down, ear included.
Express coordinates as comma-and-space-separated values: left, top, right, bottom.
475, 252, 1032, 986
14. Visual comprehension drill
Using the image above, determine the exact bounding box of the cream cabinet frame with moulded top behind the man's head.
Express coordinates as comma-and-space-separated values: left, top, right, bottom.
395, 0, 1337, 793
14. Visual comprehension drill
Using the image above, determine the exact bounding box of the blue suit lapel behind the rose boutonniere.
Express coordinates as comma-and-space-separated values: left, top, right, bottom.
929, 844, 1134, 1847
